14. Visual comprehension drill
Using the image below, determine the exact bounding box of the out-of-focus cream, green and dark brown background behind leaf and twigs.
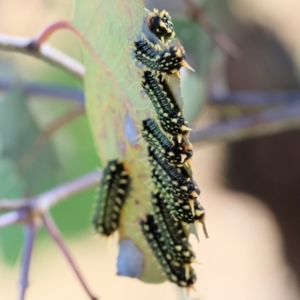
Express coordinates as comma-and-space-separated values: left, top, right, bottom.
0, 0, 300, 300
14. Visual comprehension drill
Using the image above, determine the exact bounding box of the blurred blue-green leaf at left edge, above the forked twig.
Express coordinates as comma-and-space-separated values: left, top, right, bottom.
0, 86, 58, 196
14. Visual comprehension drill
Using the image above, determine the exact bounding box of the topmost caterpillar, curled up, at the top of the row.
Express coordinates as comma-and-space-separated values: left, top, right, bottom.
146, 9, 175, 43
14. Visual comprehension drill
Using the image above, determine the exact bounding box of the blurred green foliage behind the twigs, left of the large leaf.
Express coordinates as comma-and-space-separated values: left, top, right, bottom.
0, 77, 100, 263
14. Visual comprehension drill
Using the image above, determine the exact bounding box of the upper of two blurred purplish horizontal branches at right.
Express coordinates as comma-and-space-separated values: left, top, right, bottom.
207, 90, 300, 107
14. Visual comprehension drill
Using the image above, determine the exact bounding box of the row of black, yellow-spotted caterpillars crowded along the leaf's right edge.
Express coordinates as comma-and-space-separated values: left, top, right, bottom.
134, 9, 207, 288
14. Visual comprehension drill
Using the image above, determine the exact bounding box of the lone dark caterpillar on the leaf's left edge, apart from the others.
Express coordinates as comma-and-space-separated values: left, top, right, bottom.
92, 160, 130, 236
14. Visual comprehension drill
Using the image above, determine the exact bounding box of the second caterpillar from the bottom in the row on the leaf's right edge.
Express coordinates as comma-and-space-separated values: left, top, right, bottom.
151, 192, 195, 263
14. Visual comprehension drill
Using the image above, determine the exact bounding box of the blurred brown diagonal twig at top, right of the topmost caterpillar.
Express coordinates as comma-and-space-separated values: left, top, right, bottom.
183, 0, 242, 59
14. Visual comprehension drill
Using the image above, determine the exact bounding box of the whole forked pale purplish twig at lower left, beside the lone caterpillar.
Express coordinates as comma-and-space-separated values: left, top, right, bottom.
0, 171, 102, 300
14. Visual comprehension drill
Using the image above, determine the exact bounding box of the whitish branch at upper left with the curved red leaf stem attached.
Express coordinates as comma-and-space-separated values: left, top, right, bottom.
0, 30, 85, 79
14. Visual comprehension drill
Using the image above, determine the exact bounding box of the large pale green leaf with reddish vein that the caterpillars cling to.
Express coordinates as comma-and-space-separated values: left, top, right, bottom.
73, 0, 165, 282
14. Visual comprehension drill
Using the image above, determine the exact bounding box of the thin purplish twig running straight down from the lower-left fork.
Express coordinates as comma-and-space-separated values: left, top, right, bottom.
19, 222, 38, 300
